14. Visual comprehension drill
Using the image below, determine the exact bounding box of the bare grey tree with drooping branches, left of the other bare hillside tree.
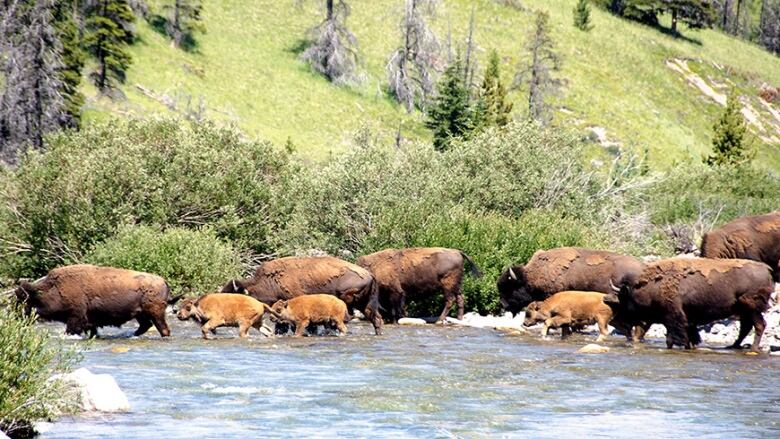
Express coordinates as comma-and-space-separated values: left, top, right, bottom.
301, 0, 358, 85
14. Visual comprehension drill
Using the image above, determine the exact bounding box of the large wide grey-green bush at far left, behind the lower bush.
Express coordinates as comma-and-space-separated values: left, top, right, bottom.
0, 120, 293, 277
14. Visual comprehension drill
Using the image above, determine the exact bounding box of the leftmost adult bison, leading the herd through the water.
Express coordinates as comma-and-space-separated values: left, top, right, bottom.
16, 265, 178, 337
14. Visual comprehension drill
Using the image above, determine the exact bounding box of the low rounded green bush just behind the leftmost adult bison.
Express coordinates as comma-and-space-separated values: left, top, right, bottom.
86, 226, 241, 295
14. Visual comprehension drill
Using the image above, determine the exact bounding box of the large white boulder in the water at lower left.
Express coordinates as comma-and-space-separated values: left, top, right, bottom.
52, 367, 130, 412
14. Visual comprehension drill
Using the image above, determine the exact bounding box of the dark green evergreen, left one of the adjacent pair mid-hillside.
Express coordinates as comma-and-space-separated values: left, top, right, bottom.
425, 54, 474, 151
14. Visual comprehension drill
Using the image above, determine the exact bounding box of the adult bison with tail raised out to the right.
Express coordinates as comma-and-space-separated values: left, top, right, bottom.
357, 247, 482, 322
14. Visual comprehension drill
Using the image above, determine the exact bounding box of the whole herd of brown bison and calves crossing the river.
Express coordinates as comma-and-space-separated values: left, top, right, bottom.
7, 213, 780, 350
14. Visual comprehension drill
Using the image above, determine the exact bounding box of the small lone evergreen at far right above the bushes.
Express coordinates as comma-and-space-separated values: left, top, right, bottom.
705, 91, 753, 166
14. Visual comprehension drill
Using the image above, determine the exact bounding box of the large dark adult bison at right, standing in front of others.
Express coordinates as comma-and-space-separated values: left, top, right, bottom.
604, 258, 775, 351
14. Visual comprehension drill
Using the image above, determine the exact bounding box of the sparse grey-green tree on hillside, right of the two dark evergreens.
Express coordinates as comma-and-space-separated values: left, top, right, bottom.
514, 11, 562, 123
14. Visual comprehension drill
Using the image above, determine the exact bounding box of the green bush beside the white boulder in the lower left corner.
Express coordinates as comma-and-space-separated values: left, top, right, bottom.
0, 304, 76, 436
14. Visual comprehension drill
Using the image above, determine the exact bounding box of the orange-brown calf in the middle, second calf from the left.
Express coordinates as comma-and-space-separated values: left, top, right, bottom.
270, 294, 350, 337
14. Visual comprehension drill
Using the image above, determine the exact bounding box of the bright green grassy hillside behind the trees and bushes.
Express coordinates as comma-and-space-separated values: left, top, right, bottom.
80, 0, 780, 169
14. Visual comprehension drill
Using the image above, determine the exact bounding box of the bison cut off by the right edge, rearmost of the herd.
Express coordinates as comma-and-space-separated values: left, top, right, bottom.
701, 212, 780, 281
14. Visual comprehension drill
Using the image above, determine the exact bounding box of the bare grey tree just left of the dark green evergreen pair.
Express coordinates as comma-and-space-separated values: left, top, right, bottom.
385, 0, 440, 111
